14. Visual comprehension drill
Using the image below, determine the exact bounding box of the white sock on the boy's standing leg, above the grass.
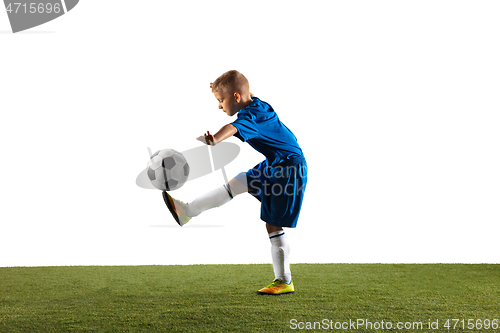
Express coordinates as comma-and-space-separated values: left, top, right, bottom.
269, 230, 292, 283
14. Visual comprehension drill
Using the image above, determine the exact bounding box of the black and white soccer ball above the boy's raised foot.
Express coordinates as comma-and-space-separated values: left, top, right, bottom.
147, 149, 189, 191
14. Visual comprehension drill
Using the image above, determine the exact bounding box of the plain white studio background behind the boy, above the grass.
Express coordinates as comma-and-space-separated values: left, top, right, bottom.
0, 0, 500, 266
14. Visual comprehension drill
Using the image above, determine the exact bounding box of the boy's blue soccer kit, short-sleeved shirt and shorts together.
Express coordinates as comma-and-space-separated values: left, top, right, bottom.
231, 97, 307, 228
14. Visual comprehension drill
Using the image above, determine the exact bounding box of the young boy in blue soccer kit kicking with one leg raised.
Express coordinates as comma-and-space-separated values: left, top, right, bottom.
163, 70, 307, 295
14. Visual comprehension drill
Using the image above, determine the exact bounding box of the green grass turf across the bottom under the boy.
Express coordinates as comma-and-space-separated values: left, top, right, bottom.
0, 264, 500, 332
